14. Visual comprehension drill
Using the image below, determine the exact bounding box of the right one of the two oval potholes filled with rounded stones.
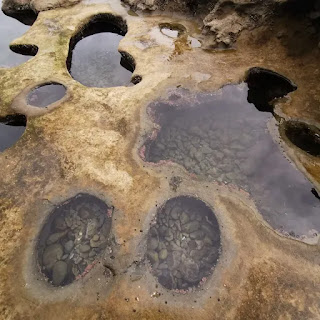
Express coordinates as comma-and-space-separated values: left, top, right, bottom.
147, 196, 221, 291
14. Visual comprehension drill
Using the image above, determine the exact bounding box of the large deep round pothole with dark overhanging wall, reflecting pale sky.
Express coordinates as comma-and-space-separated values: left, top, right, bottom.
67, 14, 135, 88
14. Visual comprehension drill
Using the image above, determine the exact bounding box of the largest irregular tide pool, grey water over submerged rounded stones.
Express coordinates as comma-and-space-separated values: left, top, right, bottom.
145, 84, 320, 237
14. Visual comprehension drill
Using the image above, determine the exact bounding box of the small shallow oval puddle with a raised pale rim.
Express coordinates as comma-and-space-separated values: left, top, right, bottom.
27, 82, 67, 108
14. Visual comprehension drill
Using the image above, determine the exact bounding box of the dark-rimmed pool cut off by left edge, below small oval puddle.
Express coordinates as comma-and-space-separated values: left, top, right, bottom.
0, 115, 27, 152
